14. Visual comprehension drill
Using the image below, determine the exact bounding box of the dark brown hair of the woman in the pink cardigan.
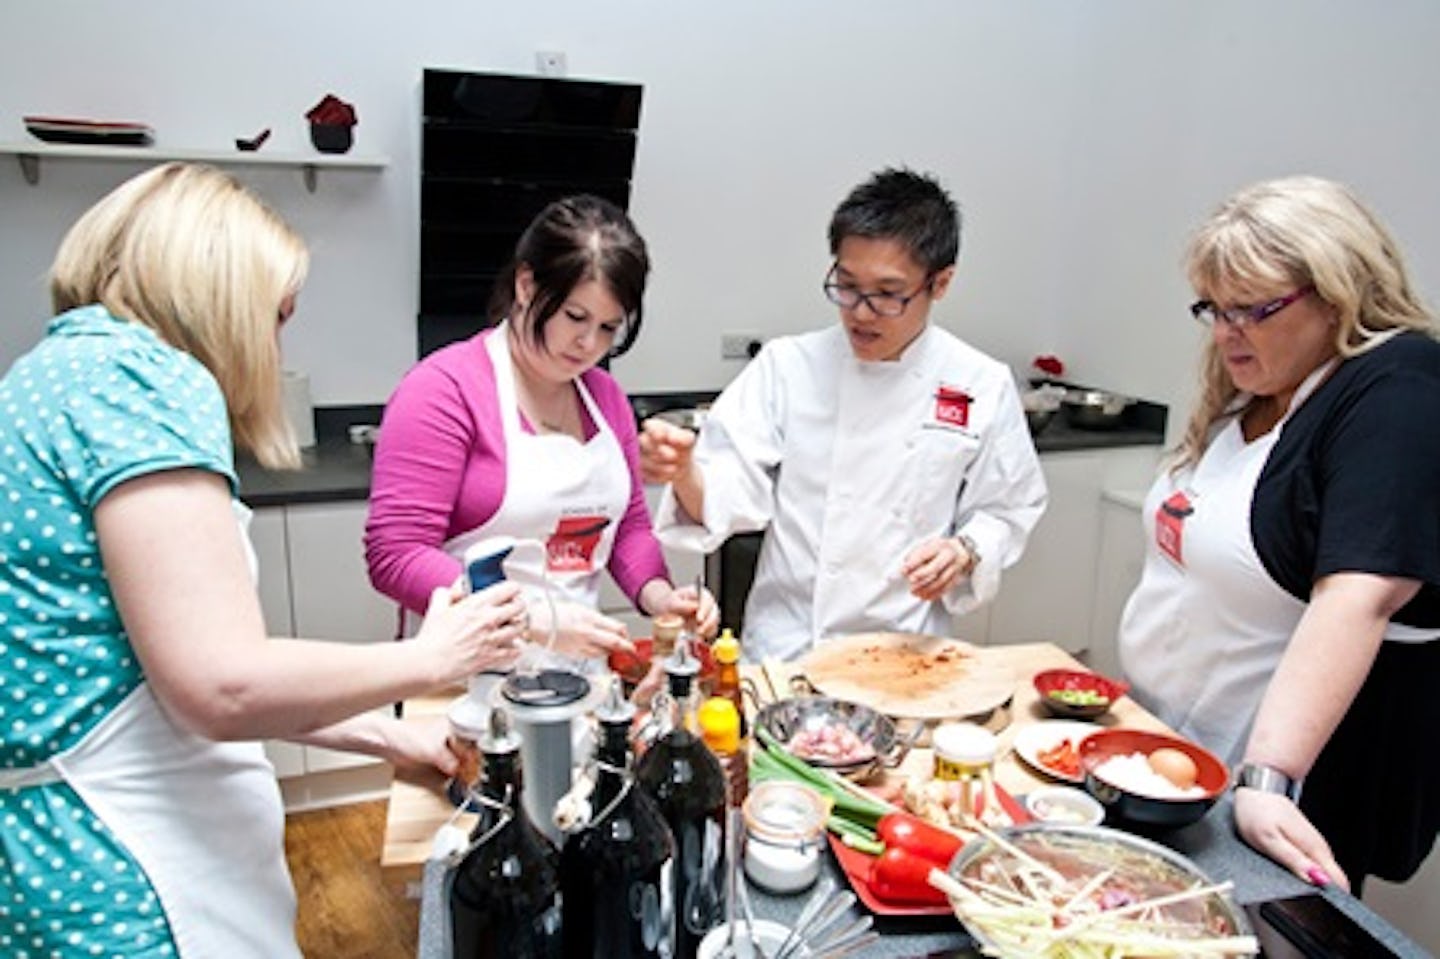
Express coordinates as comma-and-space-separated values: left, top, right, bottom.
490, 194, 649, 356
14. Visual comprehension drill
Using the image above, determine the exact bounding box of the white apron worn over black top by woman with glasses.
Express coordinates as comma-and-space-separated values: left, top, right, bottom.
1120, 364, 1331, 766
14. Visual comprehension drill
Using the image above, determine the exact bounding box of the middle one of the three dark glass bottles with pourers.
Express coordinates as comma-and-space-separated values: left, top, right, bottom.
560, 680, 675, 959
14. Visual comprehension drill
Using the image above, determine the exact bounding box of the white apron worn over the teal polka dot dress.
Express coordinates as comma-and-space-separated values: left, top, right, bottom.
0, 503, 300, 959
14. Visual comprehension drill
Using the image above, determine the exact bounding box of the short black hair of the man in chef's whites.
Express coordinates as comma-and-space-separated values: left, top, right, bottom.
829, 167, 960, 275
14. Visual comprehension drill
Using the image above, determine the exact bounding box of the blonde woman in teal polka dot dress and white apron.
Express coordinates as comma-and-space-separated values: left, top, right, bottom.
0, 164, 535, 959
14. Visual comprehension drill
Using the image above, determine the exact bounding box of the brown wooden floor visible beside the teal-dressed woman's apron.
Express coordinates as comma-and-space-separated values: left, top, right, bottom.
285, 801, 420, 959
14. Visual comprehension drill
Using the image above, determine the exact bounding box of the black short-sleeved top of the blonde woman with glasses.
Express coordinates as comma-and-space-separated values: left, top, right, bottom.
1250, 333, 1440, 628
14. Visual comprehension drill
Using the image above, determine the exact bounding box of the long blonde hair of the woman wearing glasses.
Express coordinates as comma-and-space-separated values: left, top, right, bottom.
1171, 177, 1436, 469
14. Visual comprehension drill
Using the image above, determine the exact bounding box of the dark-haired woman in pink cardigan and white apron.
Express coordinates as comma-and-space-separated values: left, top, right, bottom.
366, 196, 719, 668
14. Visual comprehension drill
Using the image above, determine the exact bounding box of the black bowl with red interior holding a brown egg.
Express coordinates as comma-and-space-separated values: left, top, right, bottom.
1079, 729, 1230, 828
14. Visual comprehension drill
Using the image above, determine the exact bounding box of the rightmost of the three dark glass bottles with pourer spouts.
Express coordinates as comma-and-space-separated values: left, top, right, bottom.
635, 644, 726, 959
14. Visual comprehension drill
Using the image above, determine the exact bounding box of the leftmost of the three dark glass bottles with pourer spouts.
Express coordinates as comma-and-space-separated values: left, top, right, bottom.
449, 706, 560, 959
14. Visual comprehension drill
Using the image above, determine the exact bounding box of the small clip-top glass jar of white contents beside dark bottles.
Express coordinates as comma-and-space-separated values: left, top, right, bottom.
743, 782, 829, 894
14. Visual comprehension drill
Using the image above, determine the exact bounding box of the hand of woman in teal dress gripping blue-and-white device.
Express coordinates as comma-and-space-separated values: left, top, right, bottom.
415, 582, 527, 685
